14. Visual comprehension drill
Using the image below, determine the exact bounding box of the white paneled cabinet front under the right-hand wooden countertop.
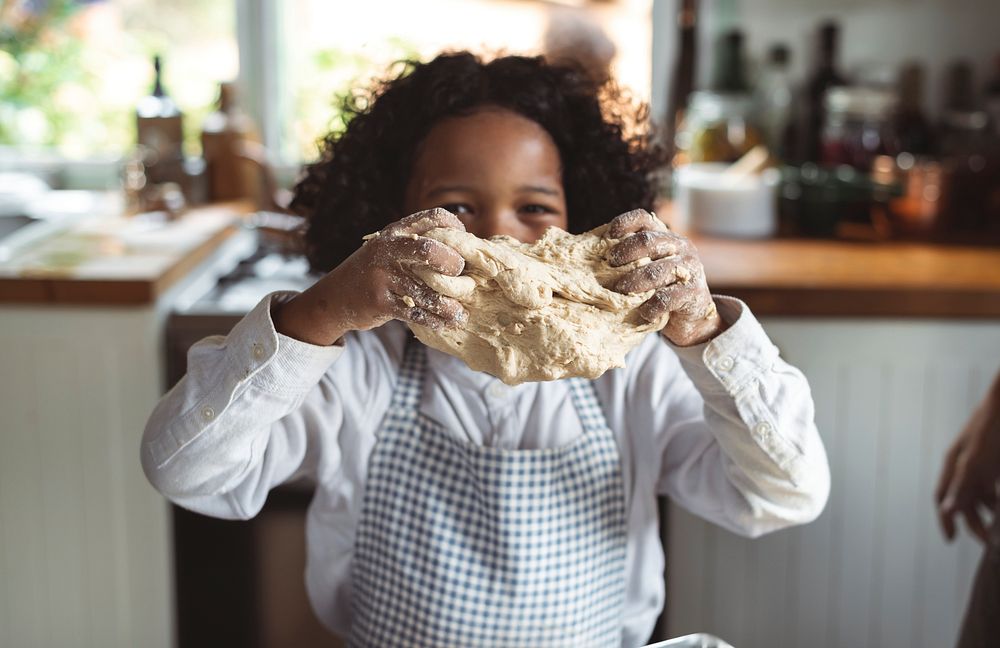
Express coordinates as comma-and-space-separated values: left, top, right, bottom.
667, 319, 1000, 648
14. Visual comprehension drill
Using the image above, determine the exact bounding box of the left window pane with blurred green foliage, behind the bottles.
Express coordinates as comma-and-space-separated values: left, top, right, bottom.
0, 0, 239, 158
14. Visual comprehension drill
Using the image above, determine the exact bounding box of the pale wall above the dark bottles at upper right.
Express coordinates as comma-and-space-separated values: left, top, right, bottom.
653, 0, 1000, 123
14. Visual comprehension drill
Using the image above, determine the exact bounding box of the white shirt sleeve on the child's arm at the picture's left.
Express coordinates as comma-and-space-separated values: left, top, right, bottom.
141, 293, 365, 519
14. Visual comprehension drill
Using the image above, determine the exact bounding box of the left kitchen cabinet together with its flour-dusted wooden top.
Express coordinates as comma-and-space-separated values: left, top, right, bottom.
0, 200, 253, 648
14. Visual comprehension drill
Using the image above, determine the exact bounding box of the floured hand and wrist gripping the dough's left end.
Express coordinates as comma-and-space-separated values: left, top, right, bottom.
273, 209, 468, 346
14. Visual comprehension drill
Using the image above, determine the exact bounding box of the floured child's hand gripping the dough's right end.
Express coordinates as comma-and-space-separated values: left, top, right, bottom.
604, 209, 724, 346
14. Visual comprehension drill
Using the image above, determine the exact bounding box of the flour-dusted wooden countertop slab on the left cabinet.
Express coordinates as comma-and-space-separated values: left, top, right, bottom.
0, 203, 251, 306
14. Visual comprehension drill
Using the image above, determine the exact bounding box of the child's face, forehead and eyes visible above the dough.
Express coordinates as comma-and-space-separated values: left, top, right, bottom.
405, 107, 567, 243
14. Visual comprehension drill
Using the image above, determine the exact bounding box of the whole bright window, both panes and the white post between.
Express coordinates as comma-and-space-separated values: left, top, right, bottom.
0, 0, 652, 165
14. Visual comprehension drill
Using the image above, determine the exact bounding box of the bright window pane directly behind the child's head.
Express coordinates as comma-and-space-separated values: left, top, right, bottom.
276, 0, 652, 160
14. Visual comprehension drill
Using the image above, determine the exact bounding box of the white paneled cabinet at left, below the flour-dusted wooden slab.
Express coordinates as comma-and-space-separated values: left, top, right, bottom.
0, 232, 255, 648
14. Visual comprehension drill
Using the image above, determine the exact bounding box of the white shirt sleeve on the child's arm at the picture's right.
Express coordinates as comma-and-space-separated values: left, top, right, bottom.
633, 296, 830, 536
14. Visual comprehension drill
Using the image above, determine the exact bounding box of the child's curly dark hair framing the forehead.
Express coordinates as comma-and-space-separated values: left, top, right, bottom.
291, 52, 664, 272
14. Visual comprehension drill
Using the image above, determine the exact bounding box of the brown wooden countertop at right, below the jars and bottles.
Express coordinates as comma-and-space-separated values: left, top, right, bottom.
691, 235, 1000, 318
